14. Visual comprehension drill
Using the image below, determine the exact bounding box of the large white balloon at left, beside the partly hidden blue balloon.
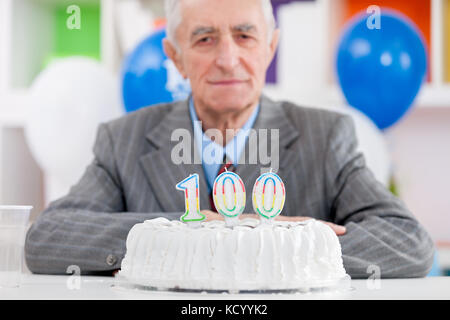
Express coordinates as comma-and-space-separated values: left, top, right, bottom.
25, 57, 124, 201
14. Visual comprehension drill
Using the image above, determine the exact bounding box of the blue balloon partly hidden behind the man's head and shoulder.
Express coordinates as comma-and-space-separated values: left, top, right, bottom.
122, 29, 190, 112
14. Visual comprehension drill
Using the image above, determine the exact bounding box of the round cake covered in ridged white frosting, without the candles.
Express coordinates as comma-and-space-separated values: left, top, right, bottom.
119, 218, 346, 290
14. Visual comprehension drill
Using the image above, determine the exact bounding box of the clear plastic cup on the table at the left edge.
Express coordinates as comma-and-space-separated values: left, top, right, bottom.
0, 206, 33, 288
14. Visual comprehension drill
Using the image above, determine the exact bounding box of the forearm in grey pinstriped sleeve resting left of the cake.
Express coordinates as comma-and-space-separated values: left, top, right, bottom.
25, 209, 181, 274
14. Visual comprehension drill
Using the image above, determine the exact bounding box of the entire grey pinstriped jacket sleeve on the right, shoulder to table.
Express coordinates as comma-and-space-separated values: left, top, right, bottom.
324, 116, 434, 278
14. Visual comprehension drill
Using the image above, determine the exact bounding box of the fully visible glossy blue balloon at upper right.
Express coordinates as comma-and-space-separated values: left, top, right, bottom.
337, 11, 427, 129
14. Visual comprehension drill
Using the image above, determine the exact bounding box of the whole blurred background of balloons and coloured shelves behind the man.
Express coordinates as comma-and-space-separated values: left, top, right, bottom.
0, 0, 450, 275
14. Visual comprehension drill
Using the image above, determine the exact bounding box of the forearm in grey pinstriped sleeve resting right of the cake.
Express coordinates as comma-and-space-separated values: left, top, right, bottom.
339, 216, 434, 279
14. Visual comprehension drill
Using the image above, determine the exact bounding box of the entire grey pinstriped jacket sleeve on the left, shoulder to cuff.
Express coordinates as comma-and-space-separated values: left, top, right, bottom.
25, 124, 181, 274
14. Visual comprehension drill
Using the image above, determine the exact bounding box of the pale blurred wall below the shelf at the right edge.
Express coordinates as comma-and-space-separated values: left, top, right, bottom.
387, 107, 450, 242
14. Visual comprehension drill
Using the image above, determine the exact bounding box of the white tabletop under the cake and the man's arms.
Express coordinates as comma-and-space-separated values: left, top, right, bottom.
0, 274, 450, 300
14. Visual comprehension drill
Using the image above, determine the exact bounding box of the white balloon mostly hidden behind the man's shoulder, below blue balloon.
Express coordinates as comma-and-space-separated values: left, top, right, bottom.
321, 105, 392, 187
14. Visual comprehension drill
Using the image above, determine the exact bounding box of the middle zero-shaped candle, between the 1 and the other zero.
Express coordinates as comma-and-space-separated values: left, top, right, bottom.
212, 171, 245, 226
